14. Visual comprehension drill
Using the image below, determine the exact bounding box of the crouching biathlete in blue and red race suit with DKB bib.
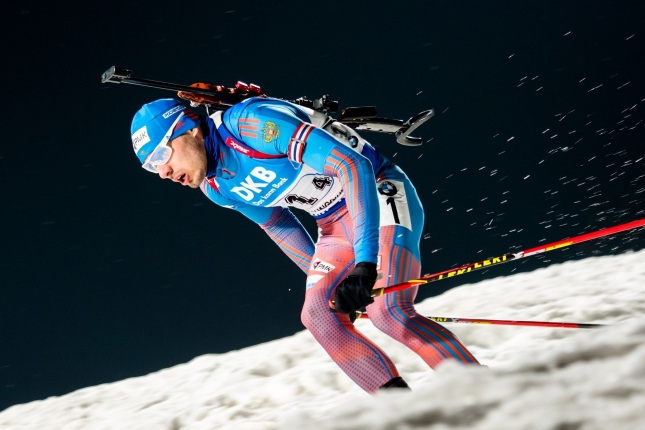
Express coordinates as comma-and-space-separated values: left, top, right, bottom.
131, 98, 478, 394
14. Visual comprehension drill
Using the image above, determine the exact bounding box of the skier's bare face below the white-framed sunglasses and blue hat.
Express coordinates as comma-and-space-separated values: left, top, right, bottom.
157, 127, 207, 188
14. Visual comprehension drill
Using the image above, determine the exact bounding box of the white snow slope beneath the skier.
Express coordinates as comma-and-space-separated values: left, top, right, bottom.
0, 250, 645, 430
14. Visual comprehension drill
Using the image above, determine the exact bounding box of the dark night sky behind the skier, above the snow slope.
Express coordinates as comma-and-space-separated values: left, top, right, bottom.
0, 0, 645, 410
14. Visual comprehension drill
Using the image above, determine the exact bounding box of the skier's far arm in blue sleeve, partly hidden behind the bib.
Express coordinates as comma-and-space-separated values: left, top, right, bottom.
201, 181, 314, 273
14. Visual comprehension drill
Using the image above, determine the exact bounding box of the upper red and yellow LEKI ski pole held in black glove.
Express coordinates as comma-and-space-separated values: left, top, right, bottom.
372, 218, 645, 297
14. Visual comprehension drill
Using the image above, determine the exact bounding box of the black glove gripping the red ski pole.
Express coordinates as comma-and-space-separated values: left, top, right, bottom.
334, 263, 376, 314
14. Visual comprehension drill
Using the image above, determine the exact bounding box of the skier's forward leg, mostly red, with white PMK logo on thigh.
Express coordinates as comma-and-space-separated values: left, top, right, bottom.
302, 208, 399, 394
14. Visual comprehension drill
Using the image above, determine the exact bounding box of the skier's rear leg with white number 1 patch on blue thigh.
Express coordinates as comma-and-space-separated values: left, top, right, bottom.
367, 168, 478, 368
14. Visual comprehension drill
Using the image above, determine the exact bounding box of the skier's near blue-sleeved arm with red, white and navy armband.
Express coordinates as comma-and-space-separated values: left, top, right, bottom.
235, 101, 380, 263
